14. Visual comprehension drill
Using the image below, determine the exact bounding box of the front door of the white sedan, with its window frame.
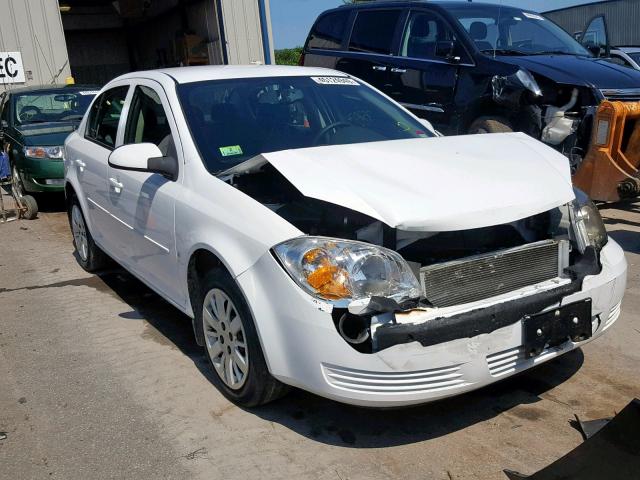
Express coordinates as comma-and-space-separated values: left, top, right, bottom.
109, 80, 185, 305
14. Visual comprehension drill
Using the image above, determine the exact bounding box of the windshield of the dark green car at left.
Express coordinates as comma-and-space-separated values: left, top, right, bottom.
15, 89, 98, 125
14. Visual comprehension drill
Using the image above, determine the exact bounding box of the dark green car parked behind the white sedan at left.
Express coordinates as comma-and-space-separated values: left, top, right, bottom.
0, 85, 97, 205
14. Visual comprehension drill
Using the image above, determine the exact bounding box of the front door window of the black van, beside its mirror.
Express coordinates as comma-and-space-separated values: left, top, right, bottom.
400, 12, 456, 59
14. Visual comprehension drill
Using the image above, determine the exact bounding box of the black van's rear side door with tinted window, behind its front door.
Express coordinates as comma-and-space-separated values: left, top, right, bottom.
336, 8, 404, 93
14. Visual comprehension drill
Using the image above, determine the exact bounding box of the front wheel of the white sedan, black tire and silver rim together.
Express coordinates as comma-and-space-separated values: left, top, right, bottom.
195, 268, 288, 407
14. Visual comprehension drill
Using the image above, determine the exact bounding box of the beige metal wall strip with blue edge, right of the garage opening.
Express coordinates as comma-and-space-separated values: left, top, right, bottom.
217, 0, 274, 65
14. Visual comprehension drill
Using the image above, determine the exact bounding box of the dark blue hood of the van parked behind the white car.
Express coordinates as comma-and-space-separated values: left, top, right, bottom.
499, 55, 640, 89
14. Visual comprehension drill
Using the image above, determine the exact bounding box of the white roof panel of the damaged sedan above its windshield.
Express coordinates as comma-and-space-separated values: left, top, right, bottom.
116, 65, 348, 84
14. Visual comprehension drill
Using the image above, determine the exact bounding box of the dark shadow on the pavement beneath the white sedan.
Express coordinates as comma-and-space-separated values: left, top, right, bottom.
100, 269, 584, 448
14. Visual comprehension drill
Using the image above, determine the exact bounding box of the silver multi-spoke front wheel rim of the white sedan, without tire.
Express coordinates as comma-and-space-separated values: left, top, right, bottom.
202, 288, 249, 390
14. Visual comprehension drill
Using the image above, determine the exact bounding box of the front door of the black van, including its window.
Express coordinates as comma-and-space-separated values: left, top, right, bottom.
388, 9, 471, 130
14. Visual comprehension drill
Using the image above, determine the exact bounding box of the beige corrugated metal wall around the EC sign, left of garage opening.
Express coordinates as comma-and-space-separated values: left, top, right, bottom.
0, 0, 71, 89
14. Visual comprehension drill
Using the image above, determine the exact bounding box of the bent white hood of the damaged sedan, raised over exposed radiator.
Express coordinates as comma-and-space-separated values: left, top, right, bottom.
249, 133, 574, 232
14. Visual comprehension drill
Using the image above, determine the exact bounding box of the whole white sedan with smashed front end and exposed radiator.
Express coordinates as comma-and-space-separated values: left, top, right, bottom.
65, 66, 626, 407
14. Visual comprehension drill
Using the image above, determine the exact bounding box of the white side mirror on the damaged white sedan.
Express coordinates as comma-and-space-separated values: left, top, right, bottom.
109, 143, 178, 181
